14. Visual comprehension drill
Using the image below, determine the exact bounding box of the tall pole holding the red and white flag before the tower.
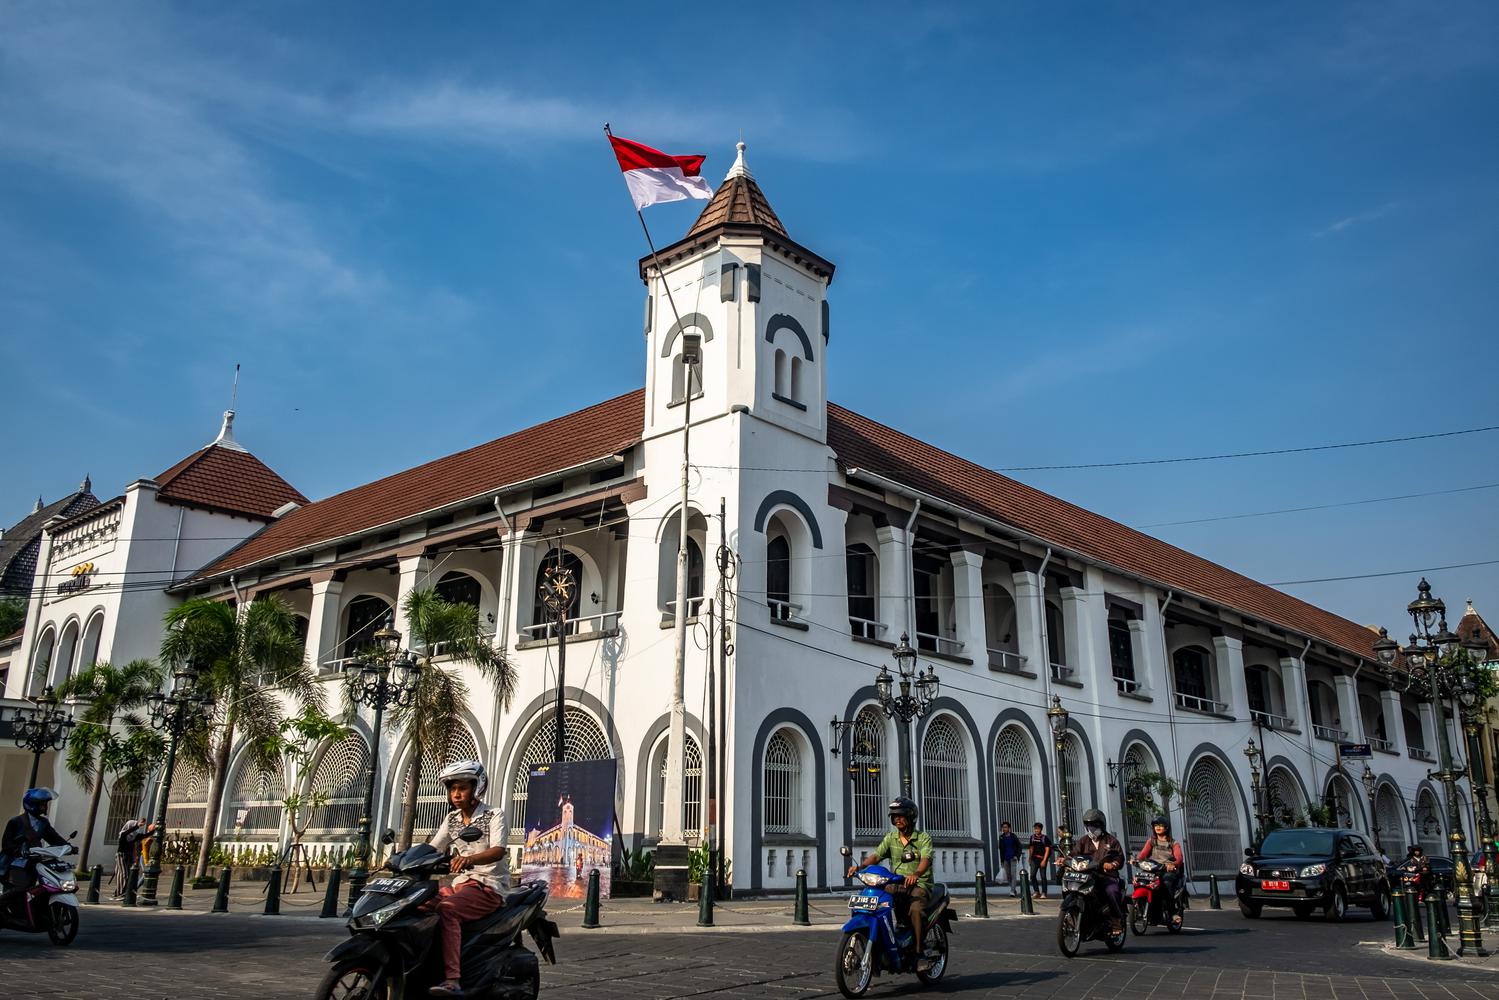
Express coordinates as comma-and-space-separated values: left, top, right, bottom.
604, 121, 693, 881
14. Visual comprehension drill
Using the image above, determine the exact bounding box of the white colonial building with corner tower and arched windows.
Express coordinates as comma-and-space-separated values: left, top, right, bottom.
10, 146, 1468, 891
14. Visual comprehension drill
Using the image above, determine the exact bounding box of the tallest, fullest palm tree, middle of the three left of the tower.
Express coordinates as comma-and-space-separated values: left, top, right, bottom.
162, 595, 322, 879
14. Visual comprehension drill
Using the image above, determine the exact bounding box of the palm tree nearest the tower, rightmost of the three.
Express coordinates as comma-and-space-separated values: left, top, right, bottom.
391, 589, 516, 847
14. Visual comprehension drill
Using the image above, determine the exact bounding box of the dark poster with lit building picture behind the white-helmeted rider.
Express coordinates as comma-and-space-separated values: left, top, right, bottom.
520, 760, 618, 900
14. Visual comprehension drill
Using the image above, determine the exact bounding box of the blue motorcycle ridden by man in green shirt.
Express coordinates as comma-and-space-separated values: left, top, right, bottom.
835, 847, 958, 1000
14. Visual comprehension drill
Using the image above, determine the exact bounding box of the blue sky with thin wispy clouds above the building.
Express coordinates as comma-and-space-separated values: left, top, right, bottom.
0, 0, 1499, 636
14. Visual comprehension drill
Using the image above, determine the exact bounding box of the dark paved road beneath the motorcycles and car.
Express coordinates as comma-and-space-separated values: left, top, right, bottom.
0, 909, 1499, 1000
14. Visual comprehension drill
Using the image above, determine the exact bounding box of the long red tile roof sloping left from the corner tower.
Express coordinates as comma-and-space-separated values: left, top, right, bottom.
196, 388, 645, 579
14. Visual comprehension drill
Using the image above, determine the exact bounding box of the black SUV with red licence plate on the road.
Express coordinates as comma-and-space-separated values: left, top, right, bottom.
1234, 826, 1390, 921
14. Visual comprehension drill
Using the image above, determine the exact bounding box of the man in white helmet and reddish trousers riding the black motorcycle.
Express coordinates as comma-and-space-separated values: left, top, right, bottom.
427, 760, 510, 997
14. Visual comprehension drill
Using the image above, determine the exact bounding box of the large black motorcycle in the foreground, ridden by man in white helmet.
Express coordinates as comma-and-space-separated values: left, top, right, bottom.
316, 826, 561, 1000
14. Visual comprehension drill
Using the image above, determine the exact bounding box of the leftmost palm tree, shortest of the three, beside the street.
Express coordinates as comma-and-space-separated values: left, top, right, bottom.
57, 660, 162, 865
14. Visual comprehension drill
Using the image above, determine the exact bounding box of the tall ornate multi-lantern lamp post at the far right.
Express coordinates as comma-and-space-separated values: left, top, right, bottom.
1375, 579, 1487, 955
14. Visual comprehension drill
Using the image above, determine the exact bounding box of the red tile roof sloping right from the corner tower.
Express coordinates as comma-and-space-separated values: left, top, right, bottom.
827, 403, 1376, 657
